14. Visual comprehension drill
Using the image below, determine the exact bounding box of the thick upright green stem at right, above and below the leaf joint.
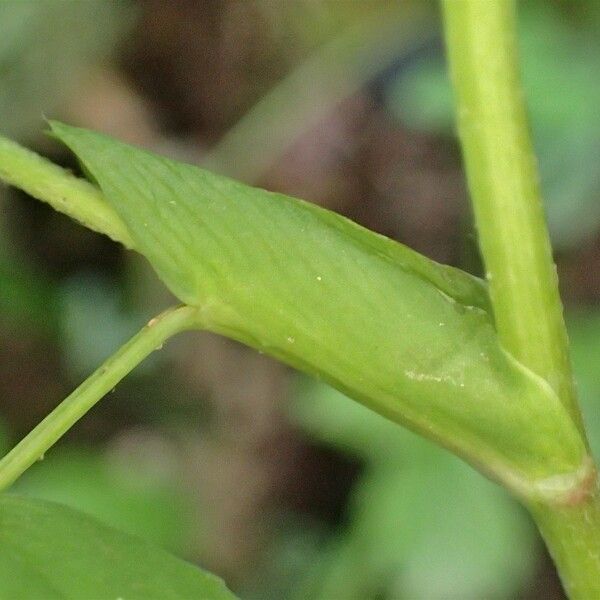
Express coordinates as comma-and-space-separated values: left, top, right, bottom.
442, 0, 600, 598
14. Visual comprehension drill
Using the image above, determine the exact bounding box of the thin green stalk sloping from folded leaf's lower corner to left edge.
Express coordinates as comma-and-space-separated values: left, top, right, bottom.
0, 306, 197, 490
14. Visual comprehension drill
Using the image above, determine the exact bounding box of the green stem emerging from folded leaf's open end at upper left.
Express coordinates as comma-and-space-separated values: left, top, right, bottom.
0, 136, 135, 249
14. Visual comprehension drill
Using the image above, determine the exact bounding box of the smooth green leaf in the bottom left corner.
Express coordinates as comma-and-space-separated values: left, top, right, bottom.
0, 495, 235, 600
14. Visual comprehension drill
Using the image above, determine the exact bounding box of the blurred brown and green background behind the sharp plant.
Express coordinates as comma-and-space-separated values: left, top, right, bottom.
0, 0, 600, 599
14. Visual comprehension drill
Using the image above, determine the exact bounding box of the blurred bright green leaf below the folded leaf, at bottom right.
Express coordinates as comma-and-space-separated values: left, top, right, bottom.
292, 382, 537, 600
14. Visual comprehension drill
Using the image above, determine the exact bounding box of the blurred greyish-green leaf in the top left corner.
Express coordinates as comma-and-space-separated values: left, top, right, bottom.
0, 0, 131, 137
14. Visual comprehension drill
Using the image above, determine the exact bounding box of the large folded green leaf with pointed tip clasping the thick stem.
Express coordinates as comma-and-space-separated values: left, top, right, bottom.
51, 122, 589, 499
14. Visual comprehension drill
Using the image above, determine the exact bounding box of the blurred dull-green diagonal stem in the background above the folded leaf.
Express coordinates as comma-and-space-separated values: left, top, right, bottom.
203, 1, 429, 183
